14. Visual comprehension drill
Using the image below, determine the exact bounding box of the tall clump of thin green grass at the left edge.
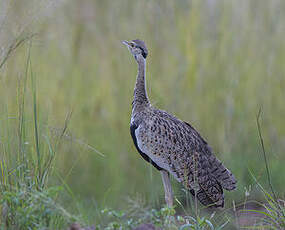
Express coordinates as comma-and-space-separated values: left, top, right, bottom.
0, 46, 79, 230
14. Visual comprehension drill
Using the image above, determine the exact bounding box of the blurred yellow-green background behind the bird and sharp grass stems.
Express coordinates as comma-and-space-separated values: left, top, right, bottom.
0, 0, 285, 211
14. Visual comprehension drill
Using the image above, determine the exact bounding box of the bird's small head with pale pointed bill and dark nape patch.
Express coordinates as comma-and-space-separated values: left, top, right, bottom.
122, 39, 148, 62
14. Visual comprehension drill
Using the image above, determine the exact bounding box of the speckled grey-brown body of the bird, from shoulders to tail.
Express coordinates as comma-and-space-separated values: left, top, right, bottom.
131, 106, 236, 207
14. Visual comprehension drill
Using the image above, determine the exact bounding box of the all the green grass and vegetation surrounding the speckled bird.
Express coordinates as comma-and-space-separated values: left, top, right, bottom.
0, 0, 285, 230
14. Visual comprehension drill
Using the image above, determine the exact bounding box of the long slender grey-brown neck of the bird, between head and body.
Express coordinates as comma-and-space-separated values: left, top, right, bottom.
132, 58, 150, 114
